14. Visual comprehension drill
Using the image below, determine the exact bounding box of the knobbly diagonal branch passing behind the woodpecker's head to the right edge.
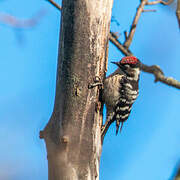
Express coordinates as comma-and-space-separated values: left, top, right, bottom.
109, 33, 180, 89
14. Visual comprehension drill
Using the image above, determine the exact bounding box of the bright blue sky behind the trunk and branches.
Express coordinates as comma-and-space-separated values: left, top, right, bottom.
0, 0, 180, 180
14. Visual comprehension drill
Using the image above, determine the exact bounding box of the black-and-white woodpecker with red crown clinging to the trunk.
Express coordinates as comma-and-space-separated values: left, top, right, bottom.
102, 56, 141, 136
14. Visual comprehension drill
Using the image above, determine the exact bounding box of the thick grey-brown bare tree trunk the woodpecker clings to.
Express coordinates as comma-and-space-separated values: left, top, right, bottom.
40, 0, 113, 180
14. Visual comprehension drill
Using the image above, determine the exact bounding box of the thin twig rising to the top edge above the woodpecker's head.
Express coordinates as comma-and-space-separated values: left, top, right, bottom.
124, 0, 148, 48
